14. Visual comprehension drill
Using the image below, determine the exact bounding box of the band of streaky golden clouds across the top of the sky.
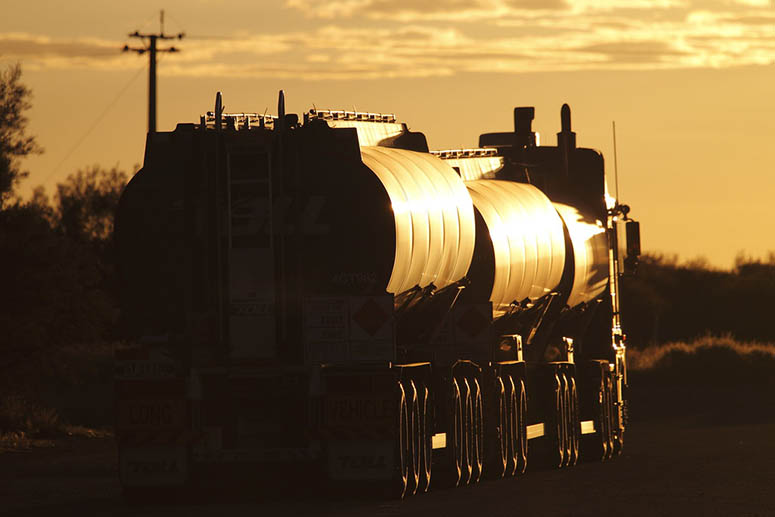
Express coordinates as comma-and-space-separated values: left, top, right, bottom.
0, 0, 775, 80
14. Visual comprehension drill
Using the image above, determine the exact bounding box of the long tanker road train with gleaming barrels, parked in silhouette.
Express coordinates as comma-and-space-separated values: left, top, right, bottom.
115, 92, 640, 497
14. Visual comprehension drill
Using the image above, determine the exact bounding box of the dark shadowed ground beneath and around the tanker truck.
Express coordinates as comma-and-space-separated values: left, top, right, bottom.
0, 380, 775, 516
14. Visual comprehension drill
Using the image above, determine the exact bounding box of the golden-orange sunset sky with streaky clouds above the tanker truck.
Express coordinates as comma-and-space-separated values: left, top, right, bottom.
0, 0, 775, 268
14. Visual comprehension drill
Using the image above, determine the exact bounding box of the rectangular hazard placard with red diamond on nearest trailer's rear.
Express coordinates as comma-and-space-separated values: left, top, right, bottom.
304, 296, 395, 364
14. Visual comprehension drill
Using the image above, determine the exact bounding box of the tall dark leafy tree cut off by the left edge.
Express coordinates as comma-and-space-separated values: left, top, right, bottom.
0, 64, 42, 210
